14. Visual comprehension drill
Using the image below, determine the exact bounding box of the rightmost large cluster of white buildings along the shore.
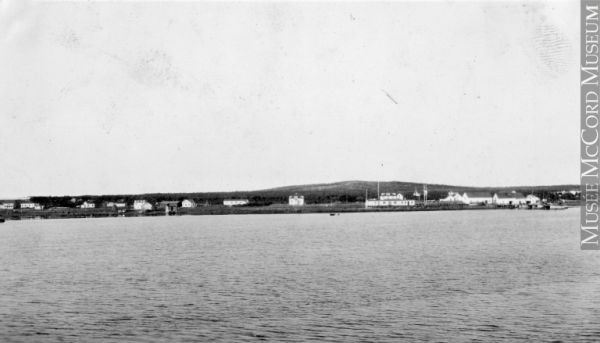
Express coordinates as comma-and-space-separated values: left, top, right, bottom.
440, 191, 541, 206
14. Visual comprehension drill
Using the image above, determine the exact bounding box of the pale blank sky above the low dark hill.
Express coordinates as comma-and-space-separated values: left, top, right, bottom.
0, 0, 579, 198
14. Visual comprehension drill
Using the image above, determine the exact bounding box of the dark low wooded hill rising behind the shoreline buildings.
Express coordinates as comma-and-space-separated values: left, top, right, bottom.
31, 180, 579, 207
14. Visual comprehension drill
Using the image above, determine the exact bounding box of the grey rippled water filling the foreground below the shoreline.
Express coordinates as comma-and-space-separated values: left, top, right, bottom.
0, 209, 600, 342
